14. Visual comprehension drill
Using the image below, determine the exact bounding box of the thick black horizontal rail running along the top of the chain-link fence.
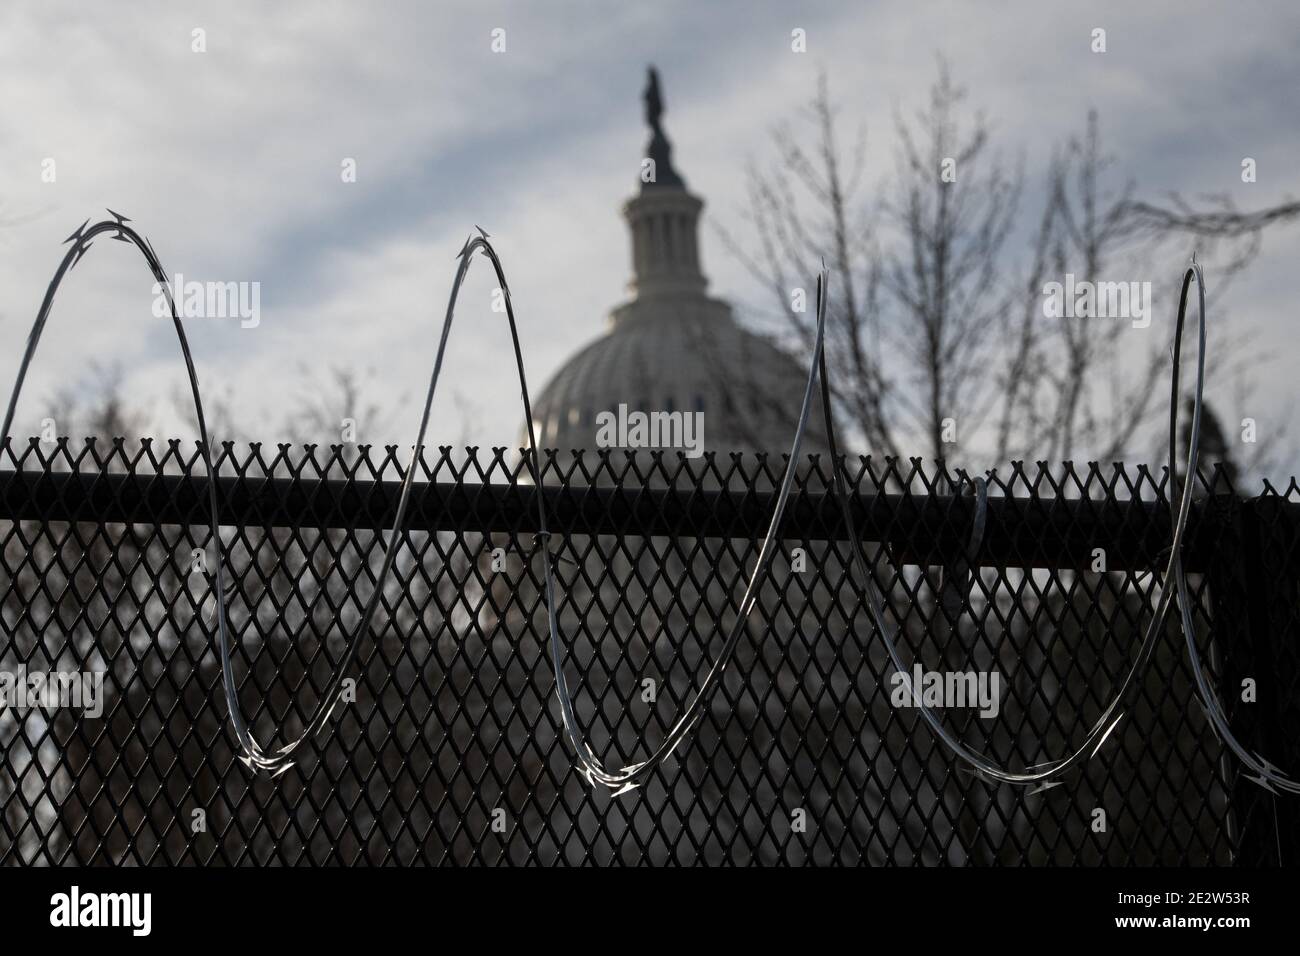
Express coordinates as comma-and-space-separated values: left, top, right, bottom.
0, 460, 1274, 571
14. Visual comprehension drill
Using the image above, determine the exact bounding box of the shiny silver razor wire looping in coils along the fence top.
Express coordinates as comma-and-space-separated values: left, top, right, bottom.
0, 209, 1300, 795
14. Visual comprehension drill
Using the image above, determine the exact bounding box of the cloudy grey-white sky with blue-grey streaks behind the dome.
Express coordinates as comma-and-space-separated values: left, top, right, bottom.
0, 0, 1300, 478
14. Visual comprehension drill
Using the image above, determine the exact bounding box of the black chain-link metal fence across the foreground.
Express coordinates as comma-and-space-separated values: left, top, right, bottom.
0, 442, 1300, 865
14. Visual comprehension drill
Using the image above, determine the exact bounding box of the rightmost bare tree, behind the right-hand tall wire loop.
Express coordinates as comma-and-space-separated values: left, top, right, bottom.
995, 111, 1257, 460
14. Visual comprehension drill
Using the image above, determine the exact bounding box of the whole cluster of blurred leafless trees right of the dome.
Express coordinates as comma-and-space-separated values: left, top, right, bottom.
723, 60, 1300, 476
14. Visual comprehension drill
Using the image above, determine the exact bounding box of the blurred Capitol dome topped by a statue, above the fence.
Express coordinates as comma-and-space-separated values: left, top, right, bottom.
523, 68, 826, 458
